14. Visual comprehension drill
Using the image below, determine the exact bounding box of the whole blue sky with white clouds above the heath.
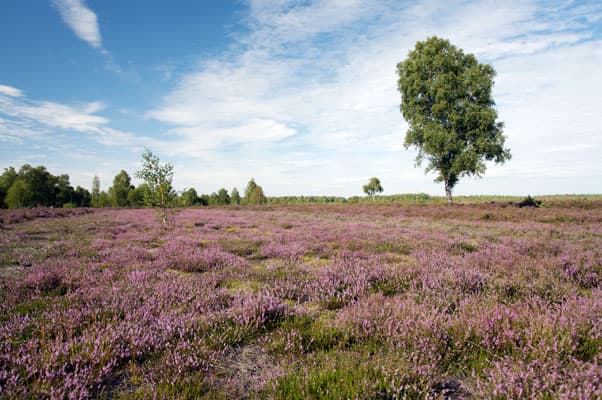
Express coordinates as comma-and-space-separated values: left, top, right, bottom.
0, 0, 602, 196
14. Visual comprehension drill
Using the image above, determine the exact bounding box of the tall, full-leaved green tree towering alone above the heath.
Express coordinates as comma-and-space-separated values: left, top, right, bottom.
397, 37, 510, 205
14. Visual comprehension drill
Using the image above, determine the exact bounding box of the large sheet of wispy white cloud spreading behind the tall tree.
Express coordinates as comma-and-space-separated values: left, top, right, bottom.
147, 0, 602, 194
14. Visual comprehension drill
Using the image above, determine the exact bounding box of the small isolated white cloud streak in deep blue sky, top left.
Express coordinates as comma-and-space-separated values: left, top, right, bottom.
52, 0, 102, 50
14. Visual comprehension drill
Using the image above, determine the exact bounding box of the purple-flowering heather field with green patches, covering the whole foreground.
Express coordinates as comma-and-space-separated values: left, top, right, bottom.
0, 205, 602, 399
